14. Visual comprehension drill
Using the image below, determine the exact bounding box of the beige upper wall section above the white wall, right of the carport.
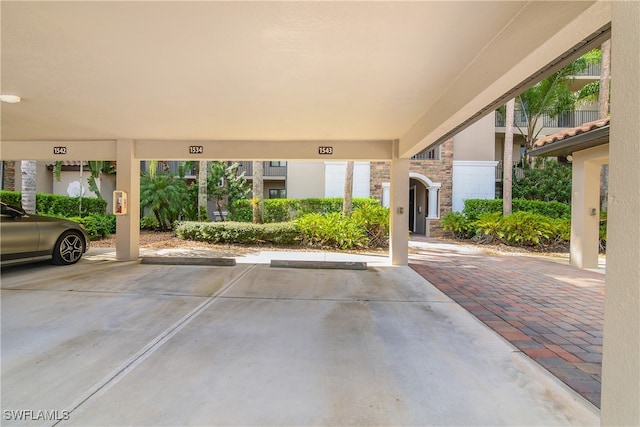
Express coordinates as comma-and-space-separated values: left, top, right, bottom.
453, 112, 496, 160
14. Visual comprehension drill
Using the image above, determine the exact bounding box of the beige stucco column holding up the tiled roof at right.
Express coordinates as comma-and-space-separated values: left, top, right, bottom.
570, 150, 606, 268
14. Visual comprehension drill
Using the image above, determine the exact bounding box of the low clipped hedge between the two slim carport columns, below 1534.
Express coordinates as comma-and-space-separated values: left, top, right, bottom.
175, 221, 299, 245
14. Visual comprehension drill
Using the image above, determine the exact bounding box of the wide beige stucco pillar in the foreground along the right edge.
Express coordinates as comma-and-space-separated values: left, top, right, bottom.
601, 1, 640, 426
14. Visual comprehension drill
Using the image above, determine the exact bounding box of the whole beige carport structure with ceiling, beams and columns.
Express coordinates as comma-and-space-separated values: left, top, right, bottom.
1, 1, 640, 425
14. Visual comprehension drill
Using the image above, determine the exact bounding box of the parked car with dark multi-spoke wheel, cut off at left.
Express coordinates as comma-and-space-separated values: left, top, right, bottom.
0, 202, 89, 266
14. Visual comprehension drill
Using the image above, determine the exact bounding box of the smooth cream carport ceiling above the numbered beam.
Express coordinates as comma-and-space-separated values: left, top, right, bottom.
1, 1, 608, 158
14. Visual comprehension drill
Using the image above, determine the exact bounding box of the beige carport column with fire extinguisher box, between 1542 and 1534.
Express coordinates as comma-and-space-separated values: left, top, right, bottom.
116, 140, 140, 261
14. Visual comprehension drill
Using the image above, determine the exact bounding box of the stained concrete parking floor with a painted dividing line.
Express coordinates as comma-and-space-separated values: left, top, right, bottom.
1, 254, 599, 426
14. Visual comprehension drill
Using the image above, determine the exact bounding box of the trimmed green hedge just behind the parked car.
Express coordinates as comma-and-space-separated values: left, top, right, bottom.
0, 190, 107, 217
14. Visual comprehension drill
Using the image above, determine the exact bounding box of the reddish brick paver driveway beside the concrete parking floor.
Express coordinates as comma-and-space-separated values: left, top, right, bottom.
409, 238, 605, 407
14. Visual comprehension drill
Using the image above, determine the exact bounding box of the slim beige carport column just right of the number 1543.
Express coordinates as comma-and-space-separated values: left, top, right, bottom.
389, 141, 409, 265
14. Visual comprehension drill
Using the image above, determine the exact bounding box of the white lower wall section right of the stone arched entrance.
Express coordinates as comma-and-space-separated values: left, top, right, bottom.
452, 160, 498, 212
